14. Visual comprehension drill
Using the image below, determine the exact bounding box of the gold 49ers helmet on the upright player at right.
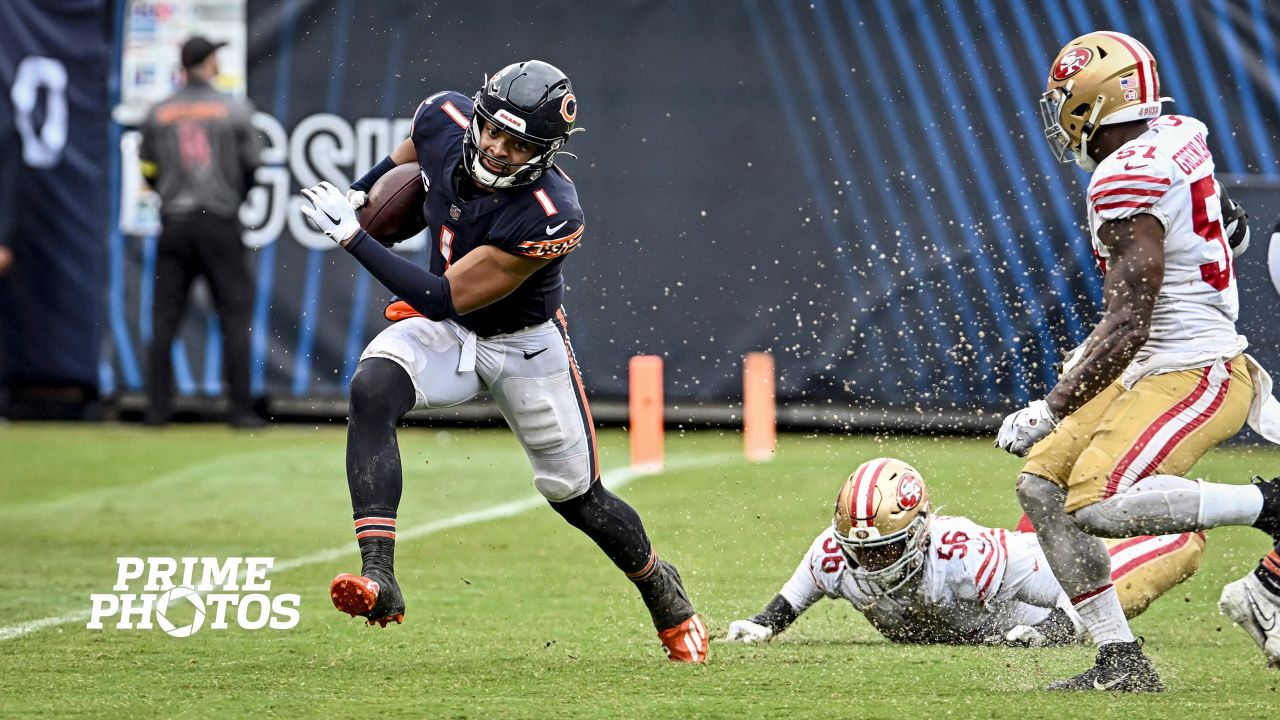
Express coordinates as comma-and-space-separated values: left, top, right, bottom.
1041, 31, 1170, 172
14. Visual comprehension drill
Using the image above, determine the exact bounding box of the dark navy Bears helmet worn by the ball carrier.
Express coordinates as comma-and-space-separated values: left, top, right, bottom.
462, 60, 577, 188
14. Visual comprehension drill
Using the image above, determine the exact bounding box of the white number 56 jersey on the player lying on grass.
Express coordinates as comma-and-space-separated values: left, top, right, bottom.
780, 515, 1065, 643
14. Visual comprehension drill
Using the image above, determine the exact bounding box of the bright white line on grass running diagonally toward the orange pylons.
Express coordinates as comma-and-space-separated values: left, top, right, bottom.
0, 455, 737, 642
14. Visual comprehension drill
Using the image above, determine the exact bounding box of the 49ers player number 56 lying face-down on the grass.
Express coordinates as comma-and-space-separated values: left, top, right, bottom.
727, 457, 1204, 646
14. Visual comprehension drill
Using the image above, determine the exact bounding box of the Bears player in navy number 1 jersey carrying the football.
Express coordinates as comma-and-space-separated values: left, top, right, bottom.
302, 60, 707, 662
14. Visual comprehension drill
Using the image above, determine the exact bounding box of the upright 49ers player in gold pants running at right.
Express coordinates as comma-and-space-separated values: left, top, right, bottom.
996, 32, 1280, 692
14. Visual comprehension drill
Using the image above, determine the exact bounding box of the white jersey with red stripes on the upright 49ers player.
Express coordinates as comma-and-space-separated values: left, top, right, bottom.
1088, 115, 1247, 383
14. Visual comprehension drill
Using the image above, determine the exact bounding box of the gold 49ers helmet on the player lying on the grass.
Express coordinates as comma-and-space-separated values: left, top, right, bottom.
832, 457, 932, 593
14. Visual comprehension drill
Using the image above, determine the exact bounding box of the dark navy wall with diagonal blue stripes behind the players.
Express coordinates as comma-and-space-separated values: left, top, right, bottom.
82, 0, 1280, 413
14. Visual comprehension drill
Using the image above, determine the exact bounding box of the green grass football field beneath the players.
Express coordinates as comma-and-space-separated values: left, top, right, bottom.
0, 424, 1280, 720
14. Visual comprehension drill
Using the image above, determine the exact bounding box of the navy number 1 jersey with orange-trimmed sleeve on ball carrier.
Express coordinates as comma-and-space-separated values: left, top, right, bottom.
411, 92, 584, 337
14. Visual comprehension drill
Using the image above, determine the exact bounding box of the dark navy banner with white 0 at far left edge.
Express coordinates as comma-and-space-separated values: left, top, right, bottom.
0, 0, 110, 404
